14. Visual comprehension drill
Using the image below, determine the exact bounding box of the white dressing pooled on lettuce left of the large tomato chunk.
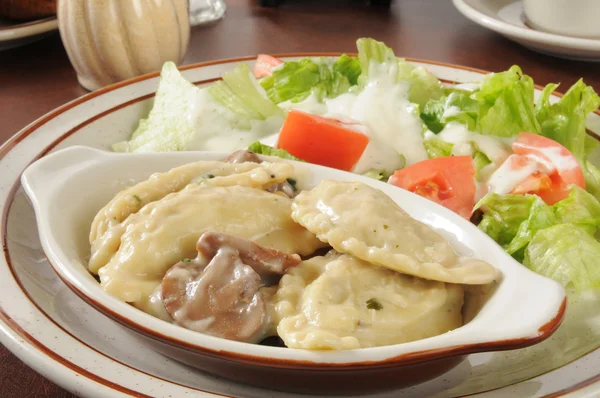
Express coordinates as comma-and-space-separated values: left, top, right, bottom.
187, 89, 283, 151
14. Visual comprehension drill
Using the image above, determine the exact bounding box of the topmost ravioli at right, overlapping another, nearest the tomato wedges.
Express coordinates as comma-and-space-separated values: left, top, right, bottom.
292, 181, 500, 284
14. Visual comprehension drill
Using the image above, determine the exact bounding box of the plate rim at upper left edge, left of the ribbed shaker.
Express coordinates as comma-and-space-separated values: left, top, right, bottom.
0, 17, 58, 51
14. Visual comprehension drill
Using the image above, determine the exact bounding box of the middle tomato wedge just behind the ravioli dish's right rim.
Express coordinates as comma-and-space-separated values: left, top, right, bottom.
388, 156, 476, 219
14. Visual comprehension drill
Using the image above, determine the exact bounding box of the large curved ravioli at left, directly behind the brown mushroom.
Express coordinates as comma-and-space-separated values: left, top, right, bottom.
98, 184, 323, 307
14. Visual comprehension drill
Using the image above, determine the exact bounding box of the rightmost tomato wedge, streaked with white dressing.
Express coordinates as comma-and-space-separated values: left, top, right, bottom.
511, 133, 585, 205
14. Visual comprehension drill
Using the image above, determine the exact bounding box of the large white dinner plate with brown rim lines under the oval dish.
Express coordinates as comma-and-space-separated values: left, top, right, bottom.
0, 54, 600, 398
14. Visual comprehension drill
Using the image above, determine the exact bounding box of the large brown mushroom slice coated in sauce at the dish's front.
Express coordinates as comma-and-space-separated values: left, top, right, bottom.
161, 232, 301, 343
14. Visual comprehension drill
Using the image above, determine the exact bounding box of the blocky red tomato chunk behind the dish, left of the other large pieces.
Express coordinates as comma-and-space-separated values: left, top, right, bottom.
277, 110, 369, 171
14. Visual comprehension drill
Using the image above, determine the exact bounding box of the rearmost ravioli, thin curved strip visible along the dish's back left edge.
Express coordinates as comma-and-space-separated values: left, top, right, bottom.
90, 161, 294, 247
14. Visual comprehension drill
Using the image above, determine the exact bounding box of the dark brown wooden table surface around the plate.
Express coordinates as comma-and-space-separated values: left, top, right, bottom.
0, 0, 600, 398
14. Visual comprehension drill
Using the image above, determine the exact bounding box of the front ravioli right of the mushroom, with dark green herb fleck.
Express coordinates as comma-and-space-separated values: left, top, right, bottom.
275, 252, 463, 350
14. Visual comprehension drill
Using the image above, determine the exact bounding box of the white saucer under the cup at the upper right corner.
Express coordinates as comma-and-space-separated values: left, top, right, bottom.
453, 0, 600, 62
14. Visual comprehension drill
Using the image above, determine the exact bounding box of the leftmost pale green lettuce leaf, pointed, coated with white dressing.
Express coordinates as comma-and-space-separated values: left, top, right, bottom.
113, 62, 283, 152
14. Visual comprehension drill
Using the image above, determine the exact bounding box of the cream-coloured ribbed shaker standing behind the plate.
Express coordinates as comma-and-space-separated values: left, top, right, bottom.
57, 0, 190, 91
